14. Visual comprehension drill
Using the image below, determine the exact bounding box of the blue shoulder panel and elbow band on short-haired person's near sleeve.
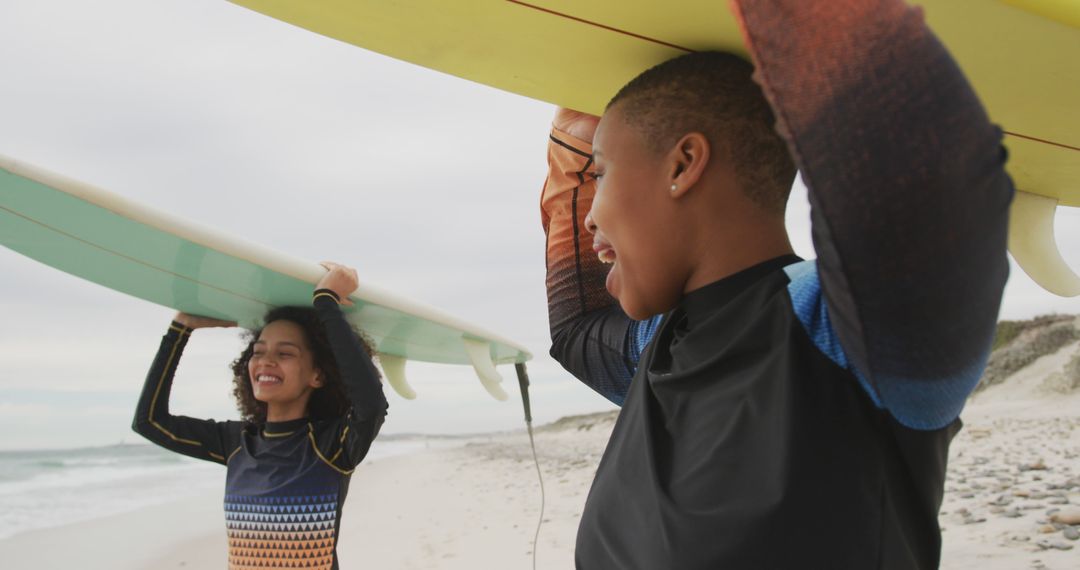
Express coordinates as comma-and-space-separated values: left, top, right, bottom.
784, 261, 989, 430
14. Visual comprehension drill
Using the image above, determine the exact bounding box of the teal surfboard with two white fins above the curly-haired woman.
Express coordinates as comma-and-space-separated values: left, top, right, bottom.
0, 157, 531, 401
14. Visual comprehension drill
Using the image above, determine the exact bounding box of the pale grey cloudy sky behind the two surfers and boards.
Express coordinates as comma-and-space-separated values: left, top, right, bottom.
0, 0, 1080, 449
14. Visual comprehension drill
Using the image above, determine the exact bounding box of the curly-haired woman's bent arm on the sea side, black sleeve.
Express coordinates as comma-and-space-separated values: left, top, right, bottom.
132, 313, 240, 464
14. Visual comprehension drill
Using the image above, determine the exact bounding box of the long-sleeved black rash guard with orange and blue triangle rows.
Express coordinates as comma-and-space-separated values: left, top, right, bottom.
134, 295, 387, 570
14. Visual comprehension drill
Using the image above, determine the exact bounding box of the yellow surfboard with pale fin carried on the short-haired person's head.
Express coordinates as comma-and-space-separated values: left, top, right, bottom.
232, 0, 1080, 297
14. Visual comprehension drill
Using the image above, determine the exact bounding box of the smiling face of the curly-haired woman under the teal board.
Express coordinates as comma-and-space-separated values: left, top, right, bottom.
247, 321, 323, 416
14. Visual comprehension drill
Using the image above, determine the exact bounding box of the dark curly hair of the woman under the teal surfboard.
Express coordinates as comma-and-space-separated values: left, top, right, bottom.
231, 307, 375, 425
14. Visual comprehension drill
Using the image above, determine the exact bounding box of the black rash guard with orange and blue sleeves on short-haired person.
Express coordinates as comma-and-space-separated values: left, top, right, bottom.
541, 0, 1013, 570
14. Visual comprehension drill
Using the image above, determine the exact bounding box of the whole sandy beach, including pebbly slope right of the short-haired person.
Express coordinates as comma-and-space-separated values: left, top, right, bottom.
0, 343, 1080, 570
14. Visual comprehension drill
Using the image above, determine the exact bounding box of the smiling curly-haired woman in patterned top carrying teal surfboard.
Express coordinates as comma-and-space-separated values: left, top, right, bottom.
133, 262, 387, 569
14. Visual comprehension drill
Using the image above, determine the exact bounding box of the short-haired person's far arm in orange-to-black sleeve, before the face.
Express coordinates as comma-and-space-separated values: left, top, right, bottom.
540, 109, 659, 405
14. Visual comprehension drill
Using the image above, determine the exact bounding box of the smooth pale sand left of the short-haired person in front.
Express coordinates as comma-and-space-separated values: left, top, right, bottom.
0, 413, 615, 570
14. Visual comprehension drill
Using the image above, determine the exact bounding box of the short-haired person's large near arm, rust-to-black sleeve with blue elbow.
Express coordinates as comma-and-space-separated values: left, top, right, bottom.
732, 0, 1013, 429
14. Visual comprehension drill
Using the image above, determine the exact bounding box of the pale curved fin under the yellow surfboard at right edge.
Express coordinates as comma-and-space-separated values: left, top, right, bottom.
1009, 191, 1080, 297
